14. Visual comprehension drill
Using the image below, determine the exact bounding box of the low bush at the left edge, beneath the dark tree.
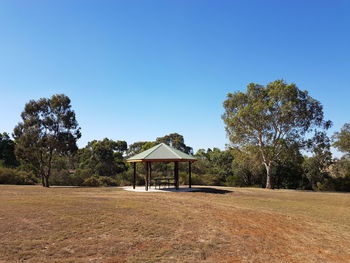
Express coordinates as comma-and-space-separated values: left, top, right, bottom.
0, 167, 38, 185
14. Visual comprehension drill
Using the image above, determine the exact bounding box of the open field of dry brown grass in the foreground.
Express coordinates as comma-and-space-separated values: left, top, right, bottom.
0, 186, 350, 263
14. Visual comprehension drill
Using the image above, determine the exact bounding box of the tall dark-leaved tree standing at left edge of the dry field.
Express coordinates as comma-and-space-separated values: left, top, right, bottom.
14, 94, 81, 187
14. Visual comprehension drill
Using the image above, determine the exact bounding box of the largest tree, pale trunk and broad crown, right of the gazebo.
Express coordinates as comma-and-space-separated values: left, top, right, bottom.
222, 80, 331, 188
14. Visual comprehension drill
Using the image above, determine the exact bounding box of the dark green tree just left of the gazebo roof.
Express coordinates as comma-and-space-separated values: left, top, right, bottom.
80, 138, 128, 176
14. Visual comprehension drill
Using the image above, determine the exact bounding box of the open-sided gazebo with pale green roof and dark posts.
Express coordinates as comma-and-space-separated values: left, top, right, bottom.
126, 143, 197, 191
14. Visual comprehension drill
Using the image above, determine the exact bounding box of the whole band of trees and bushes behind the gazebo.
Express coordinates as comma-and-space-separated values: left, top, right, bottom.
0, 80, 350, 191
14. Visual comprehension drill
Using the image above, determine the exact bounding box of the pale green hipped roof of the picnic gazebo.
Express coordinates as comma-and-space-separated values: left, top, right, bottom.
126, 143, 197, 163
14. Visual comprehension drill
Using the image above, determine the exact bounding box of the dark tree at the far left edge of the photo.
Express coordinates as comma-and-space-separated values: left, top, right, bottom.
0, 132, 18, 167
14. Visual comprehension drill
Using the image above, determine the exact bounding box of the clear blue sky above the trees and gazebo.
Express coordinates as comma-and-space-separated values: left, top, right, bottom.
0, 0, 350, 154
